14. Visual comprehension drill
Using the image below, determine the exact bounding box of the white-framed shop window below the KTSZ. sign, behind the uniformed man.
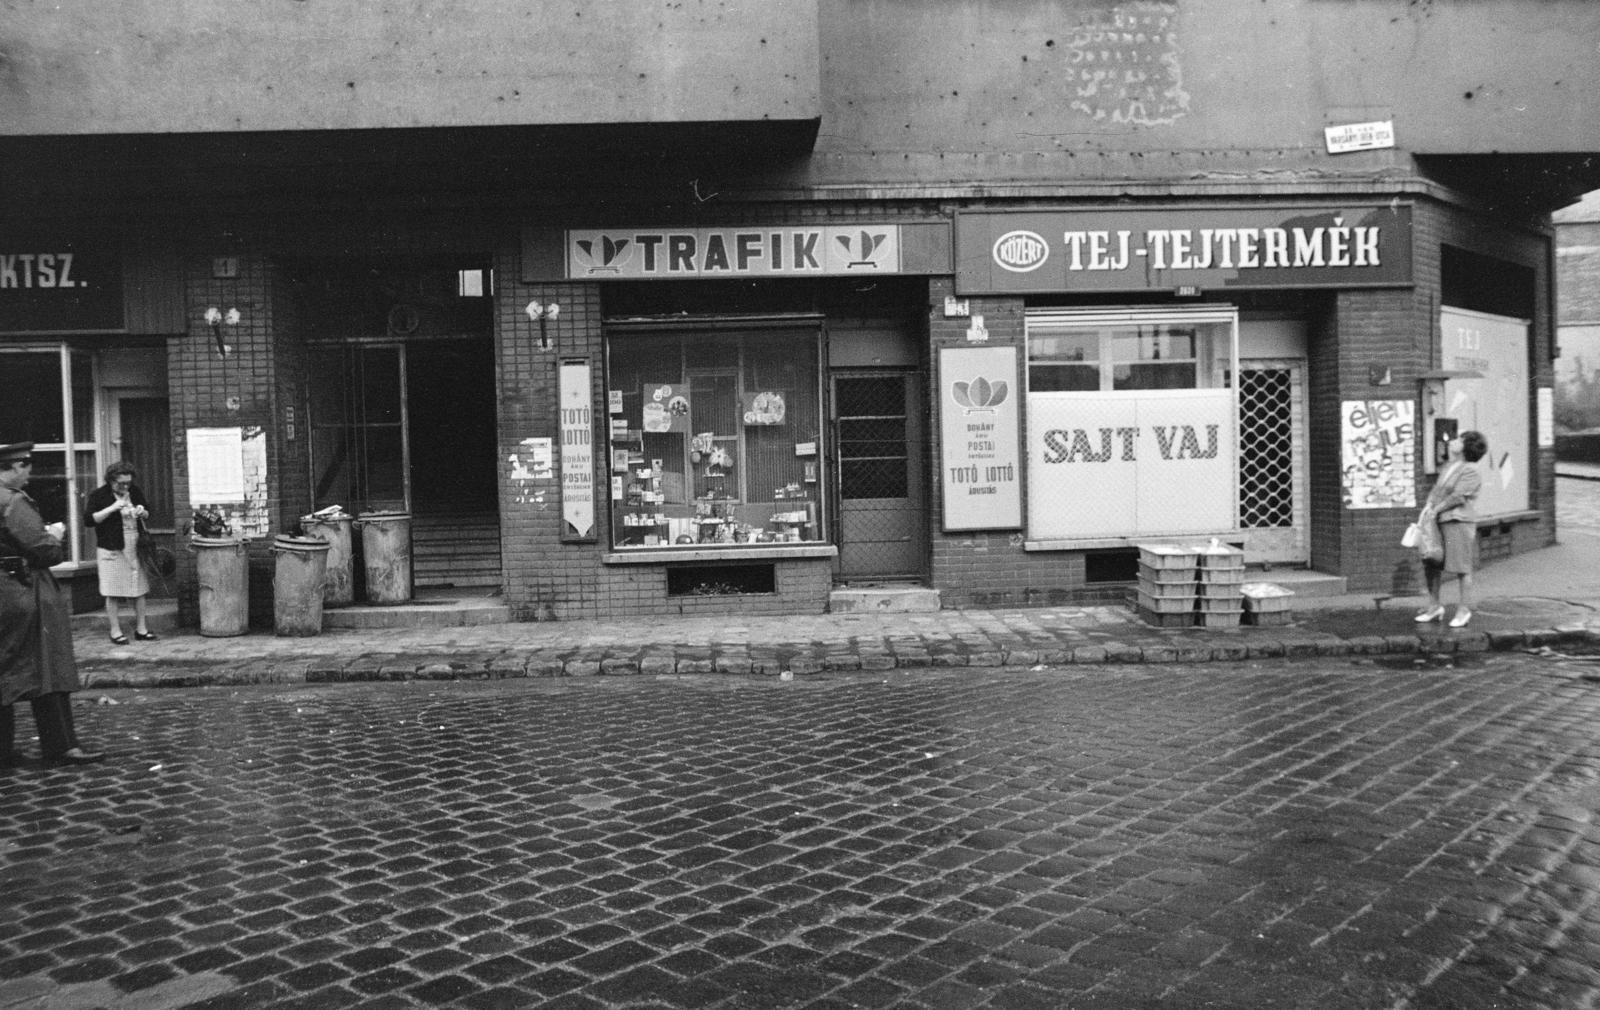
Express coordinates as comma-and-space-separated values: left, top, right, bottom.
0, 344, 99, 562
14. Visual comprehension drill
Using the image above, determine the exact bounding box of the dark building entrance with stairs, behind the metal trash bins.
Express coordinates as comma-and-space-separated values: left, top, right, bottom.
309, 339, 501, 587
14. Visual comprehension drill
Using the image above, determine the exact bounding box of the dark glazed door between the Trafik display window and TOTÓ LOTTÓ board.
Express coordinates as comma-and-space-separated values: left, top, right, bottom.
834, 371, 928, 583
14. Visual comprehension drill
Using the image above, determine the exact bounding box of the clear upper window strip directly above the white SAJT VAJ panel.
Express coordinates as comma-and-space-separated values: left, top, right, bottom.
1027, 314, 1234, 392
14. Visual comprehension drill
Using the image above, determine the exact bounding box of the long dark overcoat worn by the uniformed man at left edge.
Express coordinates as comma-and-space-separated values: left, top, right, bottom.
0, 487, 82, 704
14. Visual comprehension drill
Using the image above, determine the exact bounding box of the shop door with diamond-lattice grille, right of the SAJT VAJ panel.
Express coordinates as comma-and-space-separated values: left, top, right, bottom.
1238, 359, 1310, 565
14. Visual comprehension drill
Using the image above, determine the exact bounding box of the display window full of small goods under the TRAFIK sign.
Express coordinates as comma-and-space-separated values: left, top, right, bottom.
606, 327, 824, 551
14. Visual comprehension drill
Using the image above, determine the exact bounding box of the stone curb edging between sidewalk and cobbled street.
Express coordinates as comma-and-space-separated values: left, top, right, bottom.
82, 626, 1600, 690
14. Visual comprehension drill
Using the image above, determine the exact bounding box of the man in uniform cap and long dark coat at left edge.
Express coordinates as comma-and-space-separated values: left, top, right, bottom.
0, 442, 106, 767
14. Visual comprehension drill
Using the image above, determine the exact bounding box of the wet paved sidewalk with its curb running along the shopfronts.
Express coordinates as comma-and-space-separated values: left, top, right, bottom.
65, 535, 1600, 687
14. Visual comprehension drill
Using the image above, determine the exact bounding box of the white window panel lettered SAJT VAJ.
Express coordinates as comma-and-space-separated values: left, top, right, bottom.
1027, 389, 1238, 539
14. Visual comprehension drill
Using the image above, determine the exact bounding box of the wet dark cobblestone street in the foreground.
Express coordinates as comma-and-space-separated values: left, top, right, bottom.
9, 650, 1600, 1010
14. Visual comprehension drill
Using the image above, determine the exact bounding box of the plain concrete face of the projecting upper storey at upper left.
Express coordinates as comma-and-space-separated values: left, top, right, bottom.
0, 0, 818, 134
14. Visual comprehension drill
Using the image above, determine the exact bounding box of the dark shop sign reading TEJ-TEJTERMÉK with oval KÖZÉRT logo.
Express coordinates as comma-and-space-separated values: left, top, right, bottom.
955, 203, 1411, 295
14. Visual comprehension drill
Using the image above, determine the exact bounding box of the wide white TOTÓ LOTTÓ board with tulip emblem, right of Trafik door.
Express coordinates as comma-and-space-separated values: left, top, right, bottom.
939, 347, 1022, 530
